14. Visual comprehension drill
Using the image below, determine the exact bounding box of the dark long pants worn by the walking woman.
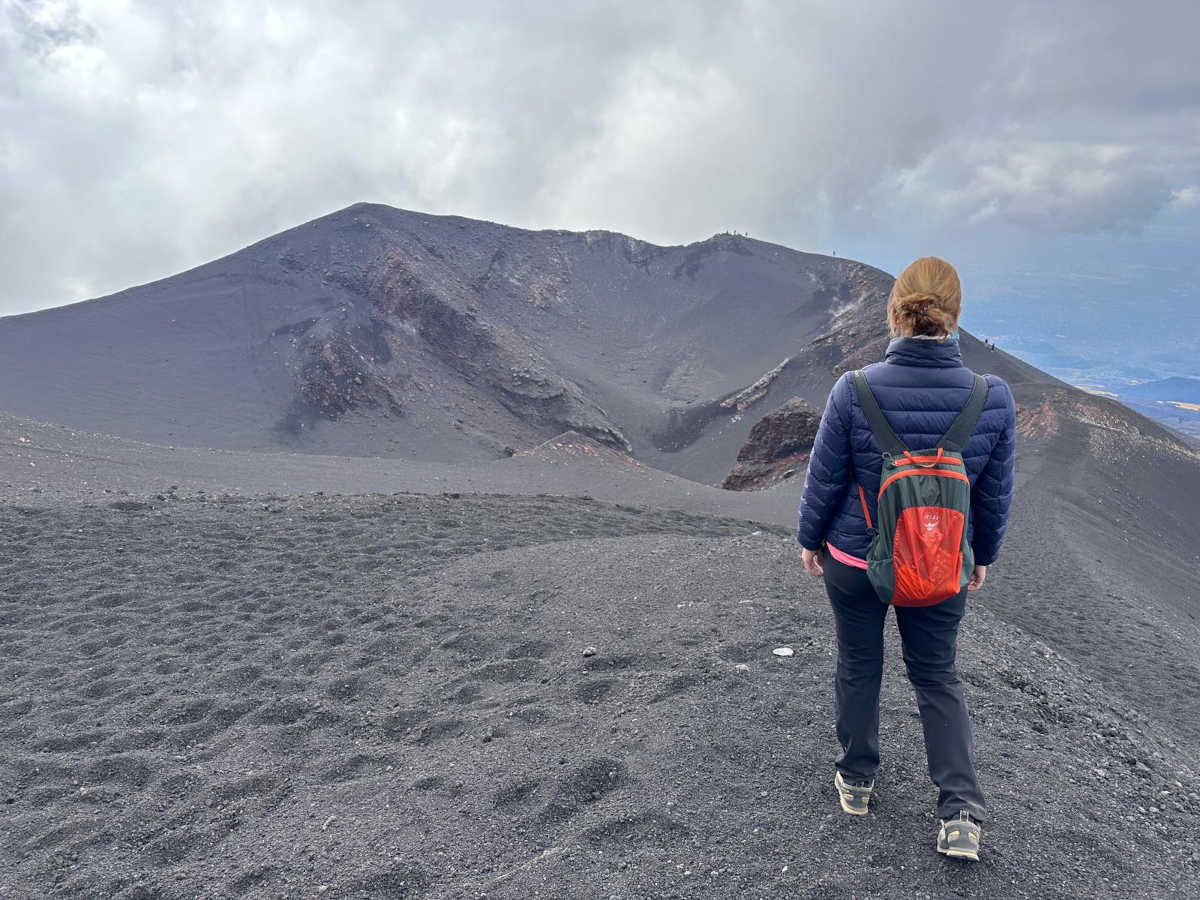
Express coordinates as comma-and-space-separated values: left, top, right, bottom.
822, 552, 986, 822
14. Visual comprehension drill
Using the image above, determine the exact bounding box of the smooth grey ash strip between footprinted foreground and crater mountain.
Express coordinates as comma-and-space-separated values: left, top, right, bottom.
0, 412, 800, 527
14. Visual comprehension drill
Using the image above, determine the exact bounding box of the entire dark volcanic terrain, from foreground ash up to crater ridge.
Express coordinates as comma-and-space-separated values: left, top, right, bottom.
0, 206, 1200, 900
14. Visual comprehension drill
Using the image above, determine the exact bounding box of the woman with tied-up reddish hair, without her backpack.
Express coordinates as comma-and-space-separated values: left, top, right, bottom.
797, 257, 1016, 859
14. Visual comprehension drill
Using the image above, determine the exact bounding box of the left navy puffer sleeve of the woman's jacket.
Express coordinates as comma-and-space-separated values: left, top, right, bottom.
796, 372, 853, 550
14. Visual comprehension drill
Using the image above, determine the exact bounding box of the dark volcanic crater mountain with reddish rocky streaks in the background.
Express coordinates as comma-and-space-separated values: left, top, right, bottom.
0, 204, 1123, 484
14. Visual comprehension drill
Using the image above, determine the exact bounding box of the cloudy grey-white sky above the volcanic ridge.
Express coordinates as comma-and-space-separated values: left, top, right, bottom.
0, 0, 1200, 374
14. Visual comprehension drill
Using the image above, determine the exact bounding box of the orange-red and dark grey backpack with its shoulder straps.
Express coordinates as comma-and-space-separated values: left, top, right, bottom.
853, 370, 988, 606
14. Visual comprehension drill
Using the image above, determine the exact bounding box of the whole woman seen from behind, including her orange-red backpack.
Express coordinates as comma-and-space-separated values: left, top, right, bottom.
797, 257, 1016, 859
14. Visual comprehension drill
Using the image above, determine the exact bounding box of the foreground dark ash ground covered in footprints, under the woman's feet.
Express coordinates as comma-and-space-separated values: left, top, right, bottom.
0, 494, 1200, 900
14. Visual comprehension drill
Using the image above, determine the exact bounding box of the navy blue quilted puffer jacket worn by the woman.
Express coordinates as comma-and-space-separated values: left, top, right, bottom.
796, 337, 1016, 565
